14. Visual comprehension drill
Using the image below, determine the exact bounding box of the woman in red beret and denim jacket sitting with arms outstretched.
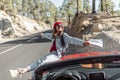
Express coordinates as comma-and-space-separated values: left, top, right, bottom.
10, 22, 89, 77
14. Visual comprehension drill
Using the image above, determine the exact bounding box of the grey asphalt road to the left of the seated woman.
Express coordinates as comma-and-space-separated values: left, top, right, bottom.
0, 32, 51, 80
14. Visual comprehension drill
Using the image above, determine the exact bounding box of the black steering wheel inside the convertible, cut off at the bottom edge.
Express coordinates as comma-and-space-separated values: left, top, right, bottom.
46, 70, 88, 80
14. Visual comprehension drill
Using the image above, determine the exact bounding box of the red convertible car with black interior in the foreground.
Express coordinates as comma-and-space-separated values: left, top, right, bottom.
33, 52, 120, 80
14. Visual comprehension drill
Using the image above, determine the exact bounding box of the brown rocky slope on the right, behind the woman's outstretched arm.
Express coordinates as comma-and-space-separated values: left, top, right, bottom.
67, 13, 120, 53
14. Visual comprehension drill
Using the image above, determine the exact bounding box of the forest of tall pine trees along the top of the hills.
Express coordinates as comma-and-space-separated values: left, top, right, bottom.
0, 0, 120, 24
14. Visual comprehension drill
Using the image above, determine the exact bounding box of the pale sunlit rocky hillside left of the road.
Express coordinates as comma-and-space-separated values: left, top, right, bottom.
0, 11, 50, 42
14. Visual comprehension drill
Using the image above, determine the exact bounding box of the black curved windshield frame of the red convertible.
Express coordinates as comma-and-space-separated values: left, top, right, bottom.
35, 54, 120, 74
